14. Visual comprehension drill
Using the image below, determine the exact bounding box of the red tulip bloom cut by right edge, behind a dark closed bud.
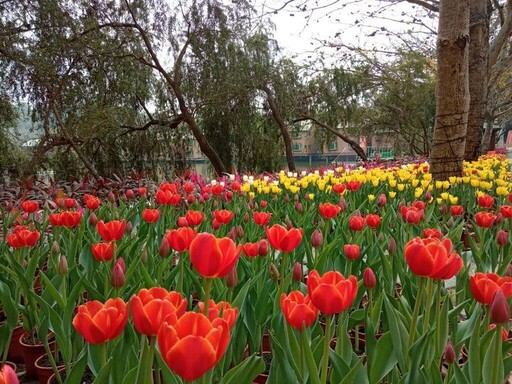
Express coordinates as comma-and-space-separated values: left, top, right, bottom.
469, 272, 512, 305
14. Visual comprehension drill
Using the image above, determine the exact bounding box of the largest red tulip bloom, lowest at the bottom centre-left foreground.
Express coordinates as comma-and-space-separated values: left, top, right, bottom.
158, 312, 229, 381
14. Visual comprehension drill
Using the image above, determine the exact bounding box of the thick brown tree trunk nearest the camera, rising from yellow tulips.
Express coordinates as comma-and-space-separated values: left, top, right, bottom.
430, 0, 469, 180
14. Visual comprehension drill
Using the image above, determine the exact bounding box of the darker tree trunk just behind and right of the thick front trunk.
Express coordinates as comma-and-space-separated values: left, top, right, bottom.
464, 0, 489, 161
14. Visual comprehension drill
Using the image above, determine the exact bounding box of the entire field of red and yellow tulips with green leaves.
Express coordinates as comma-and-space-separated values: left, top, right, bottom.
0, 153, 512, 384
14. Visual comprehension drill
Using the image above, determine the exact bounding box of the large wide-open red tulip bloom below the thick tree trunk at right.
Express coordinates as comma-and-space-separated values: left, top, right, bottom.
404, 237, 463, 280
